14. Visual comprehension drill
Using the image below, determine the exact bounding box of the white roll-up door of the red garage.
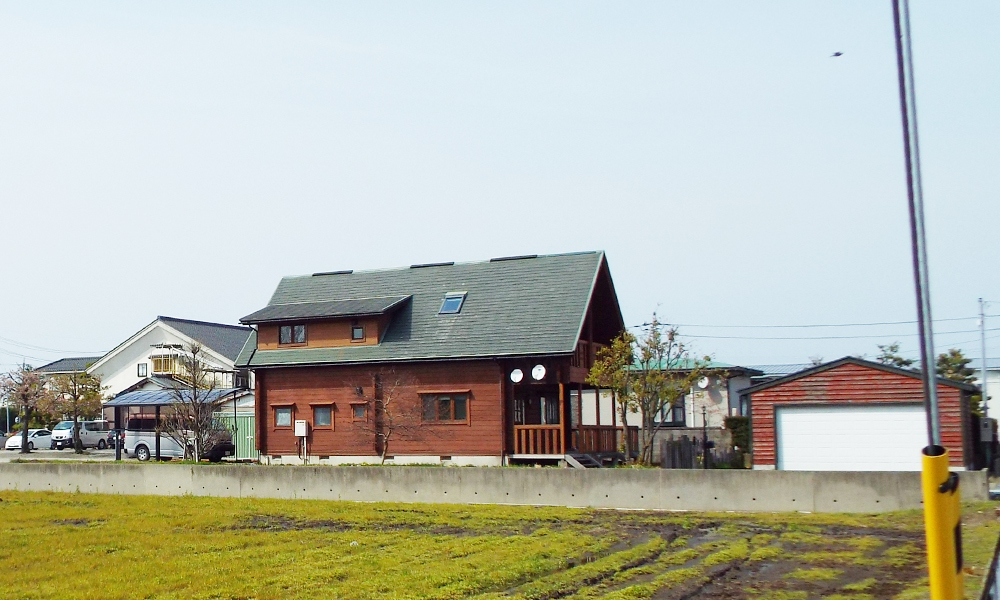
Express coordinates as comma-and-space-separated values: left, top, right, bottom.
775, 404, 927, 471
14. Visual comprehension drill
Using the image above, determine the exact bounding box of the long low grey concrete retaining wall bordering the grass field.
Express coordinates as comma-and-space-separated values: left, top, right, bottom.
0, 463, 988, 512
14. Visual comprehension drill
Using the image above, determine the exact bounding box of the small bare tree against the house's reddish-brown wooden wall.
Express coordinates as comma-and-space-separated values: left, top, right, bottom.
354, 368, 433, 464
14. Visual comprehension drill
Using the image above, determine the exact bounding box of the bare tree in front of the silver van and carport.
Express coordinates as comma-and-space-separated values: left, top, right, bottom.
157, 342, 229, 462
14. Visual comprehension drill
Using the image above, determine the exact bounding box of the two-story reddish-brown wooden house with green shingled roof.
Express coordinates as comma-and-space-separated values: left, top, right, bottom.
236, 252, 637, 465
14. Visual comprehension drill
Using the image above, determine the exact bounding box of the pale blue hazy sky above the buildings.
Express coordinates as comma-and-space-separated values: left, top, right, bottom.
0, 0, 1000, 370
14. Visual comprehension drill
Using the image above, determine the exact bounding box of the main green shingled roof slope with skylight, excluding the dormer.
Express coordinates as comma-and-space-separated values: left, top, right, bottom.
236, 252, 620, 367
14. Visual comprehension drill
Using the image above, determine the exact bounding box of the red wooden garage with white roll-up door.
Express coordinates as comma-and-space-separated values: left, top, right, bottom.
744, 357, 979, 471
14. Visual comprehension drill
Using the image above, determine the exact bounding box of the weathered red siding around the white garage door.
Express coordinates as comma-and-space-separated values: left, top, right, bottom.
750, 364, 968, 467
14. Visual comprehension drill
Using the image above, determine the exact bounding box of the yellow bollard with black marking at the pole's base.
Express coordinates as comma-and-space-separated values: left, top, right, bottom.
921, 446, 963, 600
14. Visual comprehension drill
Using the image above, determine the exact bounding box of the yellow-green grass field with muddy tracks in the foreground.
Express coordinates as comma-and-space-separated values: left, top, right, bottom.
0, 492, 1000, 600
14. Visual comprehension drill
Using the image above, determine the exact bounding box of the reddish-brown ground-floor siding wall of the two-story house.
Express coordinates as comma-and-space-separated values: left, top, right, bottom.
257, 361, 504, 458
